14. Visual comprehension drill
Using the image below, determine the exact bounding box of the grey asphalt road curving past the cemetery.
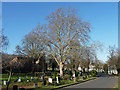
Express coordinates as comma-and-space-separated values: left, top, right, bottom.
59, 73, 118, 90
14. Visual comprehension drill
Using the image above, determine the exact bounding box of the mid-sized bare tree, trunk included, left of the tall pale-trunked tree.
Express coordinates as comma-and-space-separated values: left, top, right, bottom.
15, 32, 45, 72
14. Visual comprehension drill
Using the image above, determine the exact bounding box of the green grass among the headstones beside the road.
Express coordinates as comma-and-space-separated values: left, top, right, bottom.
2, 74, 96, 90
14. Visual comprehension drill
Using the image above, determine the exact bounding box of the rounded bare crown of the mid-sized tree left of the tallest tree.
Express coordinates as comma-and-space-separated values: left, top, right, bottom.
21, 32, 44, 58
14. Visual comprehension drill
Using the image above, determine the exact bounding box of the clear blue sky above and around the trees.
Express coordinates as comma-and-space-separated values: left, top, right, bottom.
2, 2, 118, 61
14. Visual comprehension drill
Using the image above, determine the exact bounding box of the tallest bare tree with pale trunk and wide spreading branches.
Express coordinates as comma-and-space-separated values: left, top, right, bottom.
32, 8, 90, 76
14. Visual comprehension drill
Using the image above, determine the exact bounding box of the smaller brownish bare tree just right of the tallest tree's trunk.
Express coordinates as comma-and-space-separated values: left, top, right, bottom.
66, 40, 81, 73
